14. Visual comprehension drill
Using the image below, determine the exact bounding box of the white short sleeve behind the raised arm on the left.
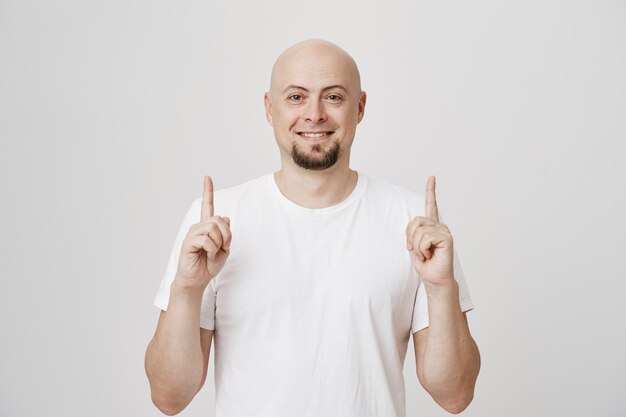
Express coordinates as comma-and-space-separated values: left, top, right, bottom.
153, 198, 215, 330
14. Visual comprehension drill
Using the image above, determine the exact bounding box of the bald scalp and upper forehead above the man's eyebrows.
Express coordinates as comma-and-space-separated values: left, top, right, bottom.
270, 39, 361, 95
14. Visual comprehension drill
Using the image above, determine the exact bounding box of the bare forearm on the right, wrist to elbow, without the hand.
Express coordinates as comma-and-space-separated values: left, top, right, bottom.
422, 281, 480, 411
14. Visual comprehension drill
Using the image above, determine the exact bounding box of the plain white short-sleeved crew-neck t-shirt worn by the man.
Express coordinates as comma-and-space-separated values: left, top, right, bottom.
154, 171, 473, 417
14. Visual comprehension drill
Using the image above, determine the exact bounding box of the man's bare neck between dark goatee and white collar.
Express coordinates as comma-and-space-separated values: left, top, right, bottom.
274, 165, 358, 209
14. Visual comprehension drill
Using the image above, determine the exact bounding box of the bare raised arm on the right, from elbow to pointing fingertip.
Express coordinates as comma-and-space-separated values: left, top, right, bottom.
407, 177, 480, 413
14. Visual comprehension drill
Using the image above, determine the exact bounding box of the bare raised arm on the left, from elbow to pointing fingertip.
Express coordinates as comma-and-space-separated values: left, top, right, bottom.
145, 177, 231, 415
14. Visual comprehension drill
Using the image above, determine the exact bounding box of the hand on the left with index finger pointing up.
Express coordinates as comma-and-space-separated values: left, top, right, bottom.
175, 176, 231, 291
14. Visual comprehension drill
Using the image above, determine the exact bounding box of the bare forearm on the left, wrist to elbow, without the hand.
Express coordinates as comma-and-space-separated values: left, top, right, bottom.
145, 280, 204, 414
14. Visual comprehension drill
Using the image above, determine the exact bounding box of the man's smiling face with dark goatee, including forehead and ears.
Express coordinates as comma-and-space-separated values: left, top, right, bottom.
265, 46, 365, 170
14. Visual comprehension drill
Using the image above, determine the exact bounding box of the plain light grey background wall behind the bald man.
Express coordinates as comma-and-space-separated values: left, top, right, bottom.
0, 0, 626, 417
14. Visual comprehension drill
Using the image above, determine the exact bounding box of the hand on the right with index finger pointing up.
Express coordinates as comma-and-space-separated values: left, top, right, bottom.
406, 176, 454, 287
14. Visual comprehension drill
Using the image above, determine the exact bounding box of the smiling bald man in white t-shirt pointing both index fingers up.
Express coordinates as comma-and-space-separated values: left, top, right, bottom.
145, 39, 480, 417
